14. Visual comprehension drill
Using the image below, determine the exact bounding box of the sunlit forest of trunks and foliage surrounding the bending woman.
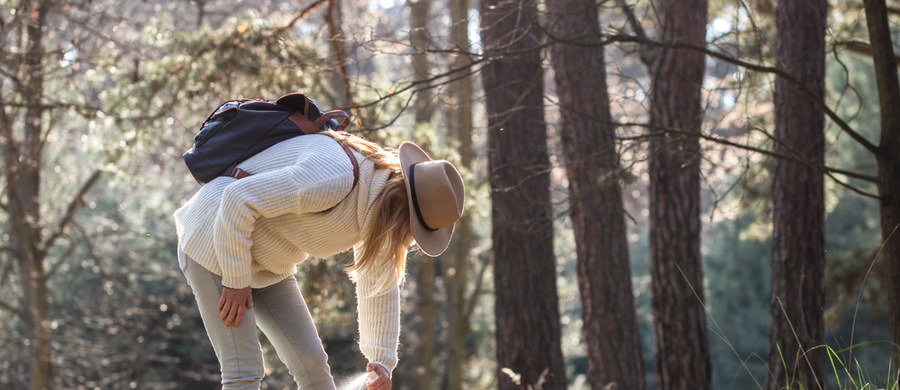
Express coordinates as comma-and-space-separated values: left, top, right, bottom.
0, 0, 900, 390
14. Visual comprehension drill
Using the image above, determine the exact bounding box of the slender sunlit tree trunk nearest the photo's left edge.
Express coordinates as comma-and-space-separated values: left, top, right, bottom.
19, 1, 55, 390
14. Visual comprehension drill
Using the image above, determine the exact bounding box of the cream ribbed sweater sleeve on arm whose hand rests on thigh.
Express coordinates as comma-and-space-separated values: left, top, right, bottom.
213, 157, 353, 288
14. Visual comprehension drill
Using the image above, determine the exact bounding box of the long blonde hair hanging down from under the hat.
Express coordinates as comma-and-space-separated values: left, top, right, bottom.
322, 130, 413, 284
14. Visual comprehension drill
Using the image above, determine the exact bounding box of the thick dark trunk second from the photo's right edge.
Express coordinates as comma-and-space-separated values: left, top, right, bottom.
766, 0, 828, 390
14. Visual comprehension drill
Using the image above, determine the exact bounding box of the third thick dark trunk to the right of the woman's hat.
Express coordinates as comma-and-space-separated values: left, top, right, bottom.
650, 0, 711, 389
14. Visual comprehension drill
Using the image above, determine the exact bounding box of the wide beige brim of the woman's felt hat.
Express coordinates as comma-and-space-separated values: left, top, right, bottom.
397, 141, 456, 257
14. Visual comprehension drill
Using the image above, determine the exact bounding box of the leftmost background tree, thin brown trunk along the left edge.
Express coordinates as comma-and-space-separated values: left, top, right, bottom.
2, 1, 55, 390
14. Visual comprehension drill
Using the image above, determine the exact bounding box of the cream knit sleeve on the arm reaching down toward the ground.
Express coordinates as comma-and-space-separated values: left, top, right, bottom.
354, 245, 400, 370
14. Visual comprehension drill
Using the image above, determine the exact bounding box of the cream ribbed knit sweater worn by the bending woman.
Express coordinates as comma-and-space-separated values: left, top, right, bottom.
175, 134, 400, 370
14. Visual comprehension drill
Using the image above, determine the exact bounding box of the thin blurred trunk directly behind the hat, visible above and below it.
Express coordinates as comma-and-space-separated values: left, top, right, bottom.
409, 0, 437, 389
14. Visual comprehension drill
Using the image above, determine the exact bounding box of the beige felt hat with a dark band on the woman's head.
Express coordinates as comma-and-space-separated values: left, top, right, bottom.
398, 142, 465, 256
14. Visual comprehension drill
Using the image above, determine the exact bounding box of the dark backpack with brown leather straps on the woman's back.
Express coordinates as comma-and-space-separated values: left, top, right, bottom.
184, 93, 359, 187
